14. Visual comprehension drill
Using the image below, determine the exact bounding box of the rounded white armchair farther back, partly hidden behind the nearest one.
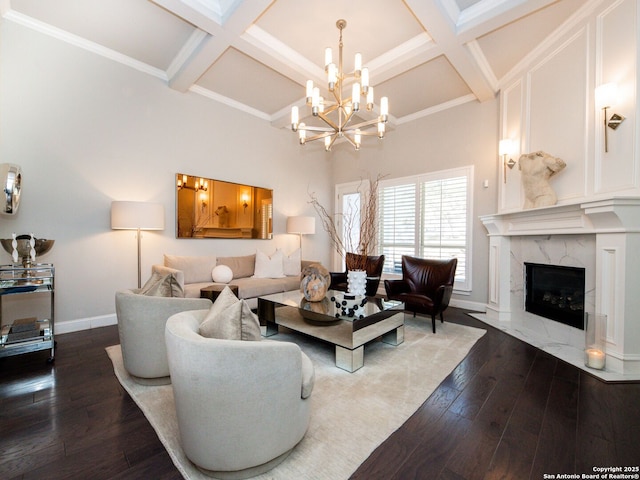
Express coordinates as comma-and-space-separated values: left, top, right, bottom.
116, 290, 211, 385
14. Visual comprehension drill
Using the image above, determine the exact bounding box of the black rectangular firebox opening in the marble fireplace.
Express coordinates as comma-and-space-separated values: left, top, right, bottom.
524, 263, 585, 330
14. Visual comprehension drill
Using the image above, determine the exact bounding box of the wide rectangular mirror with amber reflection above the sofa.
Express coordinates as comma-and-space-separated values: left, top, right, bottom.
176, 173, 273, 240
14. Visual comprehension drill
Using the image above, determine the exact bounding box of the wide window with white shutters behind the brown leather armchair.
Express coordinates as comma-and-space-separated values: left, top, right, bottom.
378, 166, 473, 291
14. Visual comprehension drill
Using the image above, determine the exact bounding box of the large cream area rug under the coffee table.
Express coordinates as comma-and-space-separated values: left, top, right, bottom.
107, 315, 485, 480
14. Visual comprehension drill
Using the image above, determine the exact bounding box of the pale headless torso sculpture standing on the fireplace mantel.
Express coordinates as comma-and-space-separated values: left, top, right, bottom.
518, 150, 567, 208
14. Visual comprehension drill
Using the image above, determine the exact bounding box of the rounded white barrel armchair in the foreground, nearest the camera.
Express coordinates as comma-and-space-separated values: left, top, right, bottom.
165, 310, 314, 479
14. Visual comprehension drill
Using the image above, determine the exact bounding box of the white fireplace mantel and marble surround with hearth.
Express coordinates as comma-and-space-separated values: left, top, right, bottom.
474, 196, 640, 381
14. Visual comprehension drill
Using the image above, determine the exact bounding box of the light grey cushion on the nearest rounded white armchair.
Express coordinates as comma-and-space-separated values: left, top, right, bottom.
198, 287, 261, 340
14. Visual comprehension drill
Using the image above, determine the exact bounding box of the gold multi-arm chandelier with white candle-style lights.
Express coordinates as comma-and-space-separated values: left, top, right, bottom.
291, 20, 389, 151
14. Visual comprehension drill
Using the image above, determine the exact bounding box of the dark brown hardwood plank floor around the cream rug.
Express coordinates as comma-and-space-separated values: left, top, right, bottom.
0, 309, 640, 480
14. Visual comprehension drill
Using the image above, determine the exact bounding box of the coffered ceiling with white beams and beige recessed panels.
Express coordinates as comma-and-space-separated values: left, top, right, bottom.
0, 0, 589, 127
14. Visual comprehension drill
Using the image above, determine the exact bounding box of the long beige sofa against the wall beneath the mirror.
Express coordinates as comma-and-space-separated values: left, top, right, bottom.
152, 254, 317, 309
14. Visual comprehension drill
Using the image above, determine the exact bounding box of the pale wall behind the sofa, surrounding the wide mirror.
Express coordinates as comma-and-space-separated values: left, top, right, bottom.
0, 21, 332, 332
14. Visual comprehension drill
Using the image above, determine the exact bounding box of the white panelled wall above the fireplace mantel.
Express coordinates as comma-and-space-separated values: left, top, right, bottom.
499, 0, 640, 212
